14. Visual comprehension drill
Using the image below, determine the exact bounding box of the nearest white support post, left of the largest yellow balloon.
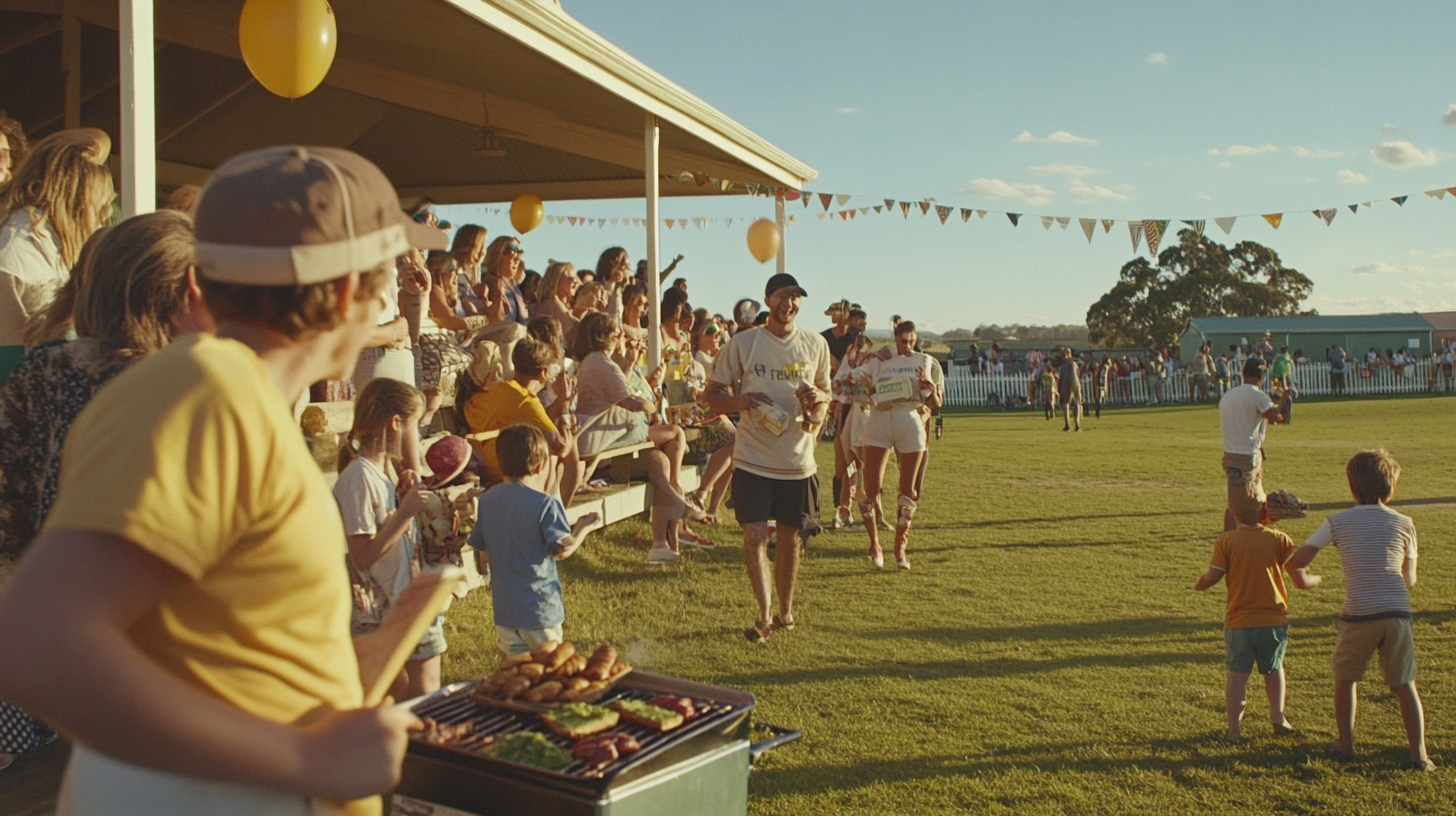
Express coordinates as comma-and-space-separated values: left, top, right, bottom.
118, 0, 157, 219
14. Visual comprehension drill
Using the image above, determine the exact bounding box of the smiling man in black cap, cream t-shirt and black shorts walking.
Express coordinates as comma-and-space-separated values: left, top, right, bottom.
708, 272, 830, 641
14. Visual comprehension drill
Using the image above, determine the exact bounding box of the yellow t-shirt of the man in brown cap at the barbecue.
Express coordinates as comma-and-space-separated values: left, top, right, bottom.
45, 335, 363, 723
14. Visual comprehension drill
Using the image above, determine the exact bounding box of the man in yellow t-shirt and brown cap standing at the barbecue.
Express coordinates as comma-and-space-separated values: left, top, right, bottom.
0, 147, 444, 816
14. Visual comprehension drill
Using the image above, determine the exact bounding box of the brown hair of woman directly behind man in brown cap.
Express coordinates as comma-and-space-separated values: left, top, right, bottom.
74, 210, 192, 360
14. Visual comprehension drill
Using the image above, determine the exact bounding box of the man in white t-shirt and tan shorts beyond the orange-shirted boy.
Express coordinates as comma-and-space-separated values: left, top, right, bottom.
1219, 357, 1284, 530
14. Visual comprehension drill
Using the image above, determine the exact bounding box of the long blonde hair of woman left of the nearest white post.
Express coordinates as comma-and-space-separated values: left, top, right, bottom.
0, 128, 116, 268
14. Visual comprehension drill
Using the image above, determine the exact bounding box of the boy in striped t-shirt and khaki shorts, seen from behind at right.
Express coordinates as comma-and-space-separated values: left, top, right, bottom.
1286, 450, 1436, 771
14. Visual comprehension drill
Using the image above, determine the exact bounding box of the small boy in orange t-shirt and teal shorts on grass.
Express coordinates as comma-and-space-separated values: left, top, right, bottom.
1192, 509, 1321, 743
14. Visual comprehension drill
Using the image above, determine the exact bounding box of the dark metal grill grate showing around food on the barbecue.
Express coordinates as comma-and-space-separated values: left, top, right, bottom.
412, 686, 741, 778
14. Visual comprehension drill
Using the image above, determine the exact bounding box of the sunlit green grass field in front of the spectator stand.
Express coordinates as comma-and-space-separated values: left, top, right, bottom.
446, 398, 1456, 815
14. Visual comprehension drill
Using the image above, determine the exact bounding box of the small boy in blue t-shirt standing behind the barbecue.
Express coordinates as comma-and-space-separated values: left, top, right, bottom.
470, 425, 600, 657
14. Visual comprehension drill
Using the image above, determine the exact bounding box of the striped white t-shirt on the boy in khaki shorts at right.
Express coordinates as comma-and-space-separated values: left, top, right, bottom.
1305, 504, 1415, 621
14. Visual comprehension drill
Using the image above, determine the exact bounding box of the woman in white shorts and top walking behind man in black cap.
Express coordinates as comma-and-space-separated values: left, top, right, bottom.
859, 321, 942, 570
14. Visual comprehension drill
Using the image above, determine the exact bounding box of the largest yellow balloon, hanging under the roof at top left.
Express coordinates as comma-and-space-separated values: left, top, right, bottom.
237, 0, 339, 99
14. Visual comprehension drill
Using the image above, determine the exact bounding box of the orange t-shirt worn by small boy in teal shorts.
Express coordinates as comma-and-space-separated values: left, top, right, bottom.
1213, 527, 1294, 629
